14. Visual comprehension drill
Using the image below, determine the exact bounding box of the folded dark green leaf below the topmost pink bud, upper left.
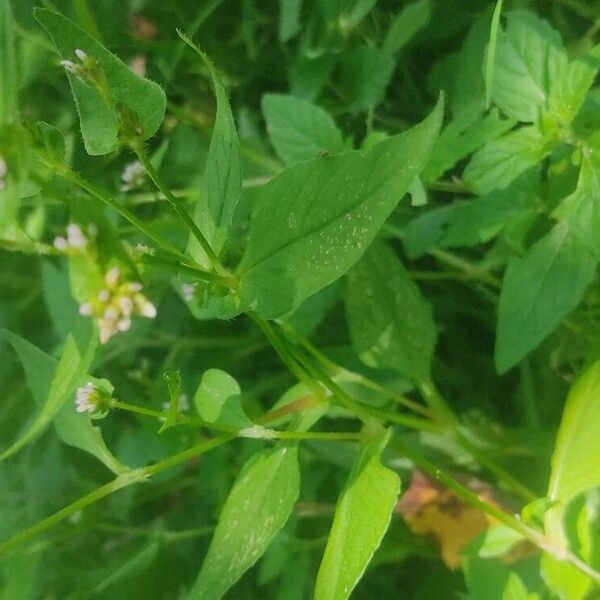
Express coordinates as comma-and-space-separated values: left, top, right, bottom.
34, 8, 166, 155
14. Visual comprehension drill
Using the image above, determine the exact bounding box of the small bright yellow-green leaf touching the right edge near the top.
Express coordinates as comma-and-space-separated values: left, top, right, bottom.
548, 44, 600, 126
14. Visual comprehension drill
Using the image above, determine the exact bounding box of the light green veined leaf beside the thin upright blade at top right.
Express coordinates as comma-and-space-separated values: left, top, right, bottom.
492, 11, 567, 122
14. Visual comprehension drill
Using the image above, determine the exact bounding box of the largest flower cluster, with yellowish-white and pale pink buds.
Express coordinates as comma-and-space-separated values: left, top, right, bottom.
79, 267, 156, 344
